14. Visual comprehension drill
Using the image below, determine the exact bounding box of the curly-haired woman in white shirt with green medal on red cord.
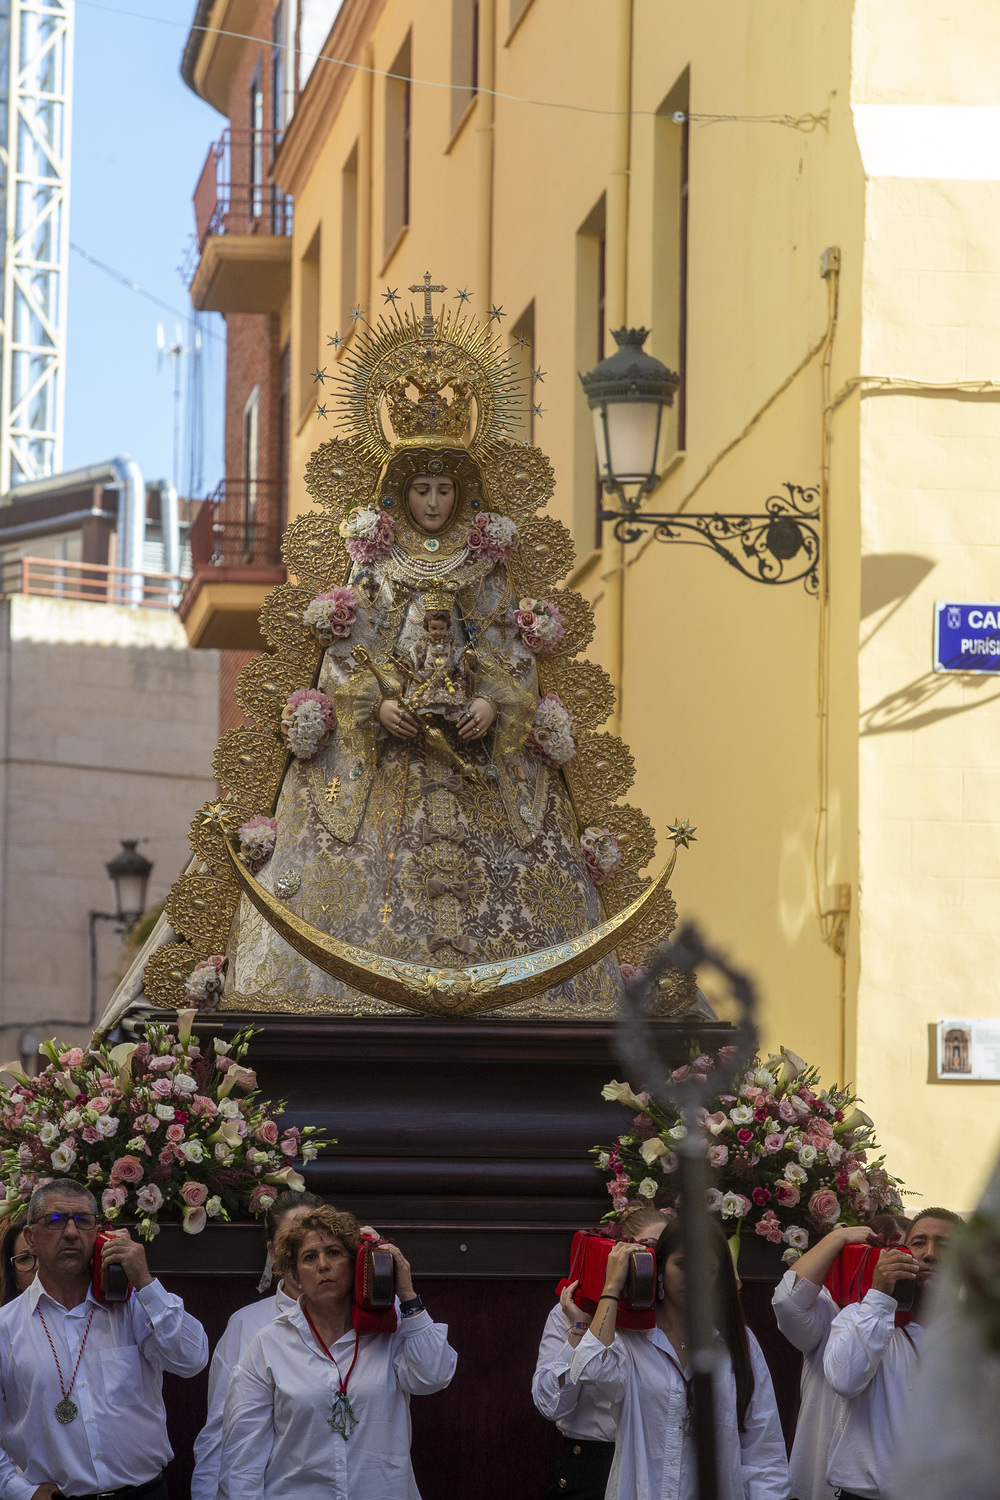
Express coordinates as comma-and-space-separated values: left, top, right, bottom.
220, 1208, 456, 1500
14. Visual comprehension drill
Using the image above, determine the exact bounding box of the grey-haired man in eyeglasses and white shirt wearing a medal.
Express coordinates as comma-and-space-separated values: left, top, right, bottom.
0, 1179, 208, 1500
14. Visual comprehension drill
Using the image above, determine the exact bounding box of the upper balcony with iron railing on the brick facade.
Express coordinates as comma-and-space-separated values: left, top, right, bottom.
187, 129, 292, 312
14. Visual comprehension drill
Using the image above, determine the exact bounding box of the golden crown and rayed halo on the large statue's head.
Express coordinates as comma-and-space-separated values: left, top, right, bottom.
333, 275, 525, 467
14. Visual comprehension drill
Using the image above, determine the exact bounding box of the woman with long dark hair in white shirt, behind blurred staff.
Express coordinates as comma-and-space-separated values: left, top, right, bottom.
570, 1220, 789, 1500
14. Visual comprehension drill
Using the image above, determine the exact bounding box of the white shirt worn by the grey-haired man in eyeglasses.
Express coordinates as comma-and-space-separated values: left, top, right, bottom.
0, 1277, 208, 1500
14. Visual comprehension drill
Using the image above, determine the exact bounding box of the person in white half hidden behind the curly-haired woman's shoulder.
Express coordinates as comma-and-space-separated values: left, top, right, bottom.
190, 1191, 322, 1500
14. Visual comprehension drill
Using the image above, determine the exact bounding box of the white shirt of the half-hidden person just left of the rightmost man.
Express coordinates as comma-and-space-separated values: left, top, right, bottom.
771, 1271, 844, 1500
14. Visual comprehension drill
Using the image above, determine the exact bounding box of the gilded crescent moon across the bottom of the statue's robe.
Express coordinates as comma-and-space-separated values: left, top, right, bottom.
225, 837, 678, 1016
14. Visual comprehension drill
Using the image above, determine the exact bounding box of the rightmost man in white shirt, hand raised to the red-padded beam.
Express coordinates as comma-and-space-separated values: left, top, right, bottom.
823, 1209, 958, 1500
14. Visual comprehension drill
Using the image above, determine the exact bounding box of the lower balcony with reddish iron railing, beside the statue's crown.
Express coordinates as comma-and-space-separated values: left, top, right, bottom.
180, 479, 286, 651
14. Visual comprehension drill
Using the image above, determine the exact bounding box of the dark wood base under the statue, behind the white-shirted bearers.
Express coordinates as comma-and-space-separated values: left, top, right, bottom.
150, 1016, 799, 1500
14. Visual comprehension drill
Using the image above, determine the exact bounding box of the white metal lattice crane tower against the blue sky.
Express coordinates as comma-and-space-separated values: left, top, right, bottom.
0, 0, 75, 495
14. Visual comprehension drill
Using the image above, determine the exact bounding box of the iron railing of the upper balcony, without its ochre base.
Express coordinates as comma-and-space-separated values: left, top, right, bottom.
193, 131, 292, 254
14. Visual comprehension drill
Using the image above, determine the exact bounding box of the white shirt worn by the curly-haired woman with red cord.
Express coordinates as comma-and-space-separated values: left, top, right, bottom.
219, 1304, 456, 1500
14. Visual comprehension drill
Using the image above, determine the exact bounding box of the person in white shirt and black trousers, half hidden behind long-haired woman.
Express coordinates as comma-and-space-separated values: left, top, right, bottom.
531, 1205, 667, 1500
